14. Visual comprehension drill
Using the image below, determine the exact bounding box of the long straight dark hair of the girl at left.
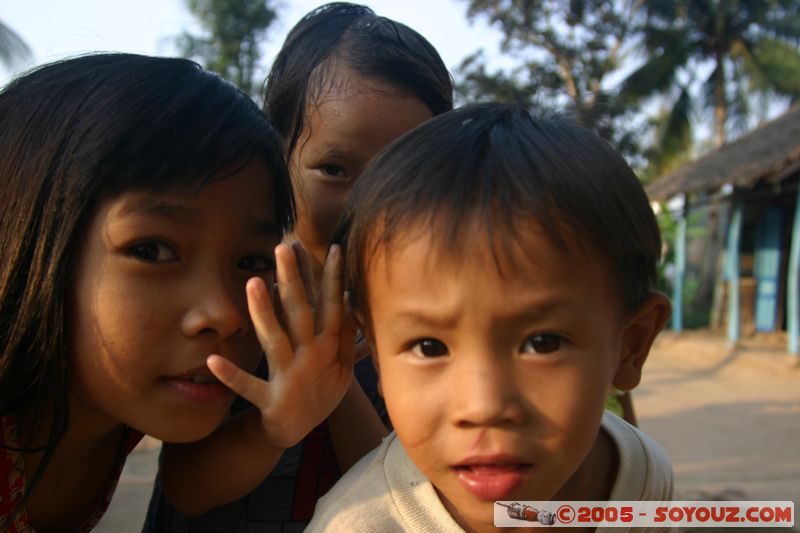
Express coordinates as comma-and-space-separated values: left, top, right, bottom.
0, 54, 294, 500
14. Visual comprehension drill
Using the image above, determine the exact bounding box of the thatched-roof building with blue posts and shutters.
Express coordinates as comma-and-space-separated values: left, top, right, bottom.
647, 105, 800, 354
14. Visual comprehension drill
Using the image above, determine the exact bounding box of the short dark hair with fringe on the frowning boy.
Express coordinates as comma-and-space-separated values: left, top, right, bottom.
336, 104, 661, 321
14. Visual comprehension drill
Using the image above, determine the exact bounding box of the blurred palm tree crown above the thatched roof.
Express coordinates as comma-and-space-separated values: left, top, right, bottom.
621, 0, 800, 156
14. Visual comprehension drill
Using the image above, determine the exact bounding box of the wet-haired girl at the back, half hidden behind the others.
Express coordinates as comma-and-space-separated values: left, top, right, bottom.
145, 3, 453, 532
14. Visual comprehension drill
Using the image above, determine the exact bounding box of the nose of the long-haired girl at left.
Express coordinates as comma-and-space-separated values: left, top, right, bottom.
182, 279, 250, 339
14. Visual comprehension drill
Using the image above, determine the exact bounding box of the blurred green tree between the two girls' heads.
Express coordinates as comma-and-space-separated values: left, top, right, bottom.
176, 0, 276, 97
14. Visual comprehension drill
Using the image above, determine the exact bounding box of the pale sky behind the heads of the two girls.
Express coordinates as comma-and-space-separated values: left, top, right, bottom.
0, 0, 500, 84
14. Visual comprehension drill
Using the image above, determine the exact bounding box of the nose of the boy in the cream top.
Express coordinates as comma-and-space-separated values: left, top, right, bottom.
451, 357, 526, 427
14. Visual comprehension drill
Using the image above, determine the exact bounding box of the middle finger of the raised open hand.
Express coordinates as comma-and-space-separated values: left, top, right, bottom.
275, 244, 314, 346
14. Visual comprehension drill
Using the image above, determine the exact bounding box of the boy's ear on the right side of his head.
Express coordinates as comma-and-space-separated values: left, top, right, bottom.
613, 293, 672, 390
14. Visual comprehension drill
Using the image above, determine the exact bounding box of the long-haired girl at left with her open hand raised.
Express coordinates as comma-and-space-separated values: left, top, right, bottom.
0, 54, 352, 532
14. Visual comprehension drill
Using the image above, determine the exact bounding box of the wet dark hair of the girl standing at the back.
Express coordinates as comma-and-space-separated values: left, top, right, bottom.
264, 2, 453, 156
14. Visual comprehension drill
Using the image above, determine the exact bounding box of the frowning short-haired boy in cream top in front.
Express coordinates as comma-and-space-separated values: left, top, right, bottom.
309, 104, 672, 531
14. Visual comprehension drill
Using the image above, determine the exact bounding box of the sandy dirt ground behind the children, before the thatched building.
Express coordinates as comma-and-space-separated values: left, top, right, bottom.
96, 331, 800, 533
